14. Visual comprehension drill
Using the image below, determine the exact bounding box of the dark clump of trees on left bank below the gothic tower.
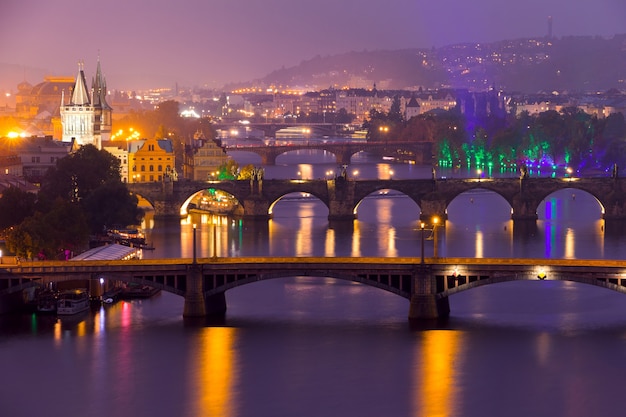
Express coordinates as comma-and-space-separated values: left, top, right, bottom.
0, 145, 141, 258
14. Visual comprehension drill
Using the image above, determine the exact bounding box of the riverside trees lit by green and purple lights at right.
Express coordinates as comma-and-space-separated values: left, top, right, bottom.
364, 107, 626, 170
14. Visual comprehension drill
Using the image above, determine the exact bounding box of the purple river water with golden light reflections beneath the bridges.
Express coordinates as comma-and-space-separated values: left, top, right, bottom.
0, 151, 626, 417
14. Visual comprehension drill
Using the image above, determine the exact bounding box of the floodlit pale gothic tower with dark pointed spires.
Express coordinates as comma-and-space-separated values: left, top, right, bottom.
60, 59, 112, 149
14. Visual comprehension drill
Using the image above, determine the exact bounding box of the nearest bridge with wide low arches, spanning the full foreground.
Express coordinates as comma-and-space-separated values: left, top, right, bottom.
0, 257, 626, 320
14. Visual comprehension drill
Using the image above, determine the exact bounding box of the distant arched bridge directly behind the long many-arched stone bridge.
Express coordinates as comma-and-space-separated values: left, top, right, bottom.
224, 142, 433, 166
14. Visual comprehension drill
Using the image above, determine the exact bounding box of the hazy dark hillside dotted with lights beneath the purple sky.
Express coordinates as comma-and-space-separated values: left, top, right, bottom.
259, 35, 626, 92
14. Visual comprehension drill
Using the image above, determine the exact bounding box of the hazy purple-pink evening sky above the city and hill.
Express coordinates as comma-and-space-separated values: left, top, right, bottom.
0, 0, 626, 90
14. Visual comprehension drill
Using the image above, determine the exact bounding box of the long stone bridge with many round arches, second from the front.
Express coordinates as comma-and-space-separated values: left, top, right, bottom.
128, 176, 626, 222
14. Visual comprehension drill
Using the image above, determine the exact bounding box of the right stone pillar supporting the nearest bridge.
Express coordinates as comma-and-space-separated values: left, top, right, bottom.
409, 265, 450, 320
